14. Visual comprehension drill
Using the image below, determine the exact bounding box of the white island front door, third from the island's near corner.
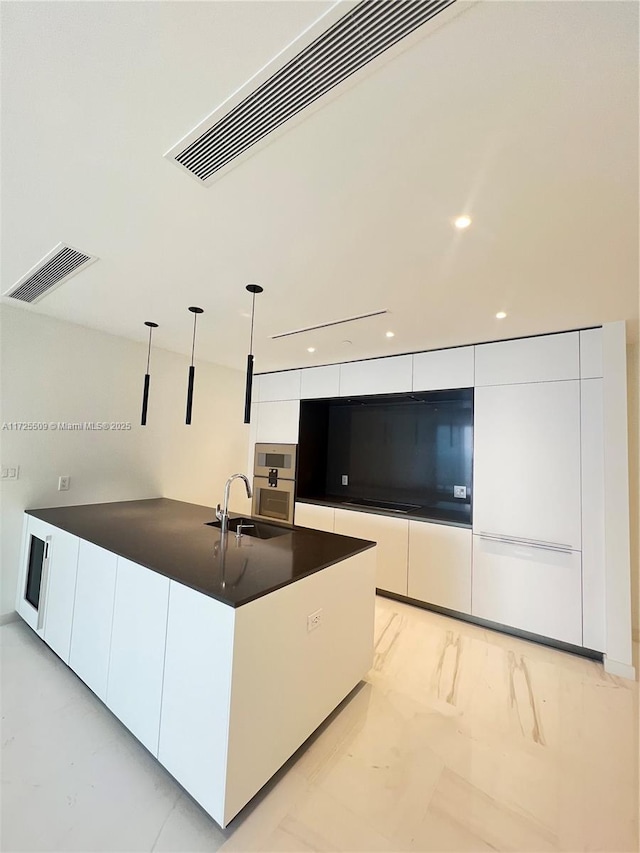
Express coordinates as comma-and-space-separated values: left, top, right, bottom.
69, 539, 118, 702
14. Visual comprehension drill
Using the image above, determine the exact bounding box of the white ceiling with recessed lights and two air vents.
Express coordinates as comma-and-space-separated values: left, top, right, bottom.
1, 0, 639, 370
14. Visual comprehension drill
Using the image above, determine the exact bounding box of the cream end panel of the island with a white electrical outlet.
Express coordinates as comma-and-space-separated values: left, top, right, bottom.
223, 548, 377, 825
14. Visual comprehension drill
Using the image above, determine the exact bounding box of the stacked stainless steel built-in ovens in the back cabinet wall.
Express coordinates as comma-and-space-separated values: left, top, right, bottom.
252, 444, 298, 524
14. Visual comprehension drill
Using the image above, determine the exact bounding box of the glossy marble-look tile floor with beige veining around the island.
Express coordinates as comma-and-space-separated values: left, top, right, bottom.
0, 598, 639, 853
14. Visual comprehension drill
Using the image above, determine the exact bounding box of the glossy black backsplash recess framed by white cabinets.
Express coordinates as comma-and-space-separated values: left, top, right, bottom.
298, 388, 473, 522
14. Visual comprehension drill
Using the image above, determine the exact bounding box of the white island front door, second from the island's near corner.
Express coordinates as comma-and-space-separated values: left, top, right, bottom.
106, 557, 169, 756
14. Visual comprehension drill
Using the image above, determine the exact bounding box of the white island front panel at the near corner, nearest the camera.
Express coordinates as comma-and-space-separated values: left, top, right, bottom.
158, 581, 235, 824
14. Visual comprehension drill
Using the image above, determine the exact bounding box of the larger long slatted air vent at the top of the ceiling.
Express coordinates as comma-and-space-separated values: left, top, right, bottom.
166, 0, 455, 182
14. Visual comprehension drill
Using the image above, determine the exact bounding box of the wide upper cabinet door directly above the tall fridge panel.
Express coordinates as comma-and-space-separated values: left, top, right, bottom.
475, 332, 580, 385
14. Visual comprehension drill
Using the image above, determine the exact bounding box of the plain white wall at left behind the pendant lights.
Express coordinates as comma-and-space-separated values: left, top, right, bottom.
0, 304, 249, 616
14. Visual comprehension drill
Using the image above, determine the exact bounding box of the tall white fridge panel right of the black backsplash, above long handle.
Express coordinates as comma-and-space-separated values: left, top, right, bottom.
473, 380, 581, 550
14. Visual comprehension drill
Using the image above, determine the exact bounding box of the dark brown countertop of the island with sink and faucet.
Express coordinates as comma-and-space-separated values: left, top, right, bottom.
27, 498, 375, 607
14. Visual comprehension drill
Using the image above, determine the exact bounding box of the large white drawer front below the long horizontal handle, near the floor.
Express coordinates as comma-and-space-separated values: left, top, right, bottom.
471, 536, 582, 646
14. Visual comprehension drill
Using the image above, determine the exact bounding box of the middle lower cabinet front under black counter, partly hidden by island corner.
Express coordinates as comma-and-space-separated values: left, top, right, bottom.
334, 509, 409, 595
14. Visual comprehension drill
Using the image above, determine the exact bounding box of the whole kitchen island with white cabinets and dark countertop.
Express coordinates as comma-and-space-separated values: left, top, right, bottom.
17, 498, 375, 826
